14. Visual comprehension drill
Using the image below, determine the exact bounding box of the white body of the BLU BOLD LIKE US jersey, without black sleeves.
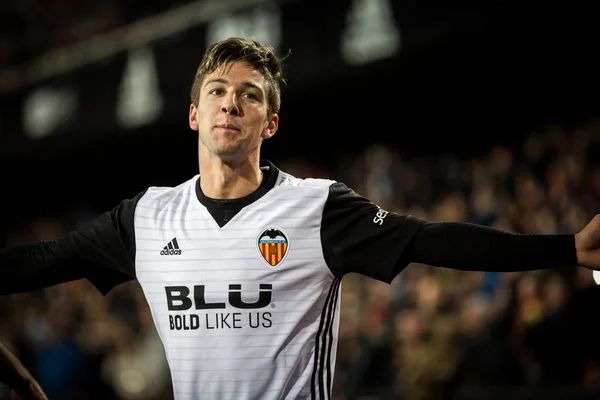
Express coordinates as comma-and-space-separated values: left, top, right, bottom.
135, 169, 340, 400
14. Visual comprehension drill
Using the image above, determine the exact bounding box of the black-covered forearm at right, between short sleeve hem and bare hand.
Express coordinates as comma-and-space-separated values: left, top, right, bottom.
411, 222, 577, 272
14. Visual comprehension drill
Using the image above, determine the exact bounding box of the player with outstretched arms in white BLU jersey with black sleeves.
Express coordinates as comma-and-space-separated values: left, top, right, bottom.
0, 38, 600, 400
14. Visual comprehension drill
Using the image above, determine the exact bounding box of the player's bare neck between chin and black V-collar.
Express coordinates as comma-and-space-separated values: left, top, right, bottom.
199, 148, 262, 199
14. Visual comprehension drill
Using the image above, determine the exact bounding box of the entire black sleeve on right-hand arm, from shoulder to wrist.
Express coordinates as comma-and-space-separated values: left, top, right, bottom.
321, 183, 577, 283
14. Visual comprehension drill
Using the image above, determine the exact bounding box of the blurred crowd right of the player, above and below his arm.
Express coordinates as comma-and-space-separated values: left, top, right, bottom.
326, 120, 600, 400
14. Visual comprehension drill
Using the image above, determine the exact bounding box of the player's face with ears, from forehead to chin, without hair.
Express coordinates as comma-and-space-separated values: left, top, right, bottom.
189, 62, 279, 161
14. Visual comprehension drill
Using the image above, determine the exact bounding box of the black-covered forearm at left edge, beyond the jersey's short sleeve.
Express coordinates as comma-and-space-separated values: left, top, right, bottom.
0, 241, 83, 295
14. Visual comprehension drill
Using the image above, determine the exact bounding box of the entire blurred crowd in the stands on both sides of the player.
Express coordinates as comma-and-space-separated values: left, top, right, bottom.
0, 120, 600, 400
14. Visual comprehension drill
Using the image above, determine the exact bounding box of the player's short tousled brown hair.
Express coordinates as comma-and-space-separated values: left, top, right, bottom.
190, 37, 285, 115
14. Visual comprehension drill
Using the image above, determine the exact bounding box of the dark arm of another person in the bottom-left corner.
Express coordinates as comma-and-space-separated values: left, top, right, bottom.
0, 343, 48, 400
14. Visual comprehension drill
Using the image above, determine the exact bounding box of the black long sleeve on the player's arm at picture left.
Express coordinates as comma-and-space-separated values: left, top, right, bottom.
0, 191, 145, 295
